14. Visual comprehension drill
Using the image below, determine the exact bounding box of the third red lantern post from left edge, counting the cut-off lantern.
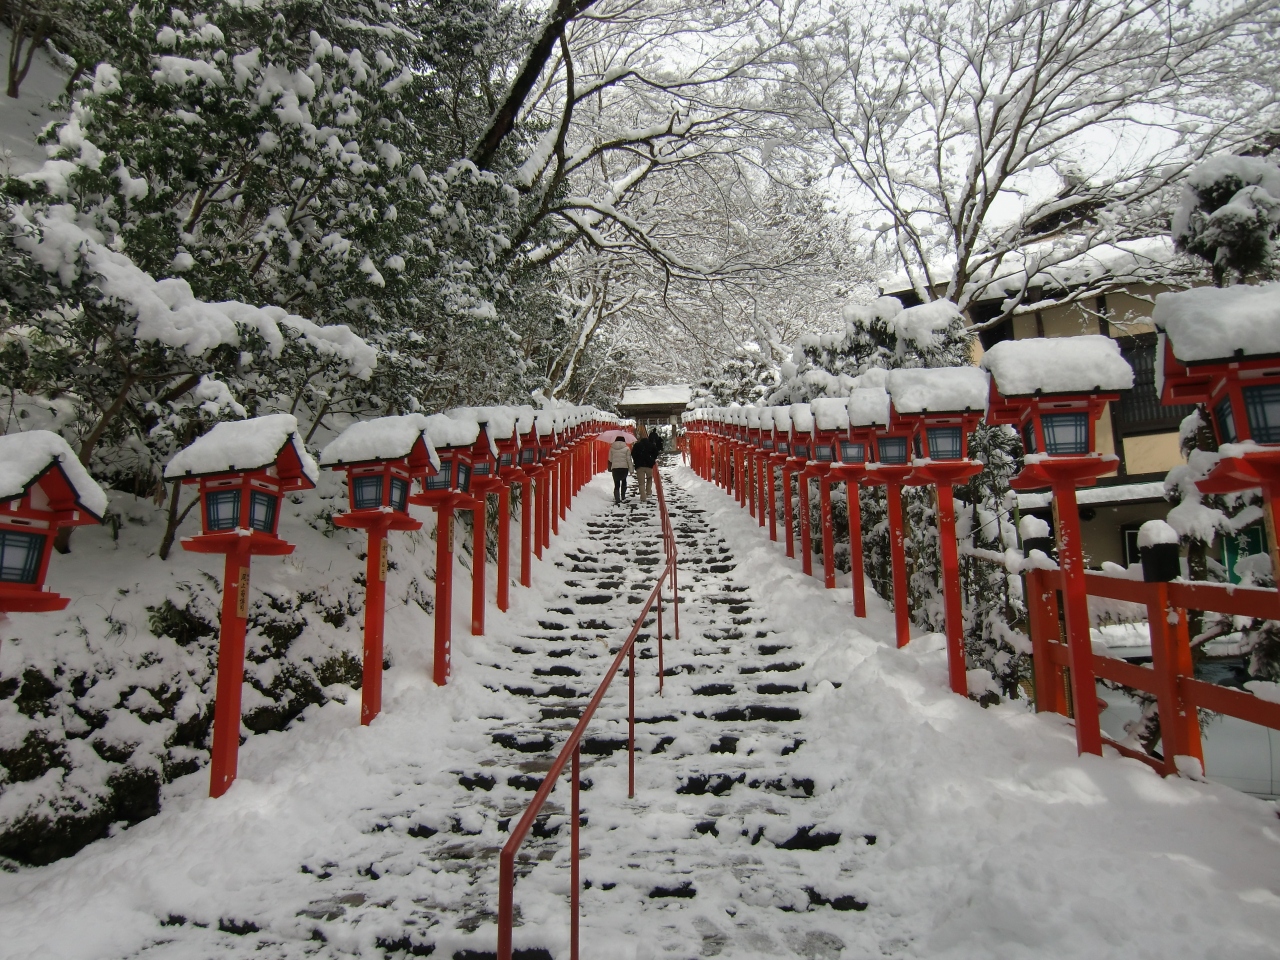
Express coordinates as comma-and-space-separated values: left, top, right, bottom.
320, 413, 434, 726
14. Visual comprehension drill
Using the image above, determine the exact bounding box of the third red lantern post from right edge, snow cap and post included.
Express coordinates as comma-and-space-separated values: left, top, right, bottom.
886, 367, 989, 696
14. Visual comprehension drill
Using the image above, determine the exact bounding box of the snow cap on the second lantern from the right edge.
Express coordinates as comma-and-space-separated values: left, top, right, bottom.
982, 334, 1133, 397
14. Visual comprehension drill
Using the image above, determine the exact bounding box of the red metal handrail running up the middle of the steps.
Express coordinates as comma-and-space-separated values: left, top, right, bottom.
498, 467, 680, 960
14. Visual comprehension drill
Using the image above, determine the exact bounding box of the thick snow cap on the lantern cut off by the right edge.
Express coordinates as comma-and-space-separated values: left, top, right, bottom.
1151, 283, 1280, 364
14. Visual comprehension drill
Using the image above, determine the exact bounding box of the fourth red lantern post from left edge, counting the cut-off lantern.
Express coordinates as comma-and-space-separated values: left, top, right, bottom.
410, 413, 479, 686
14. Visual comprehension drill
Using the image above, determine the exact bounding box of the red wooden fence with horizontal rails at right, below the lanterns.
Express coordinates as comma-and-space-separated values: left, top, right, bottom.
1027, 570, 1280, 774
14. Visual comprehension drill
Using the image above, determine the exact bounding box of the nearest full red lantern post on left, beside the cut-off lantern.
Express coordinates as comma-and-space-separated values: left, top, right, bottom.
164, 413, 319, 796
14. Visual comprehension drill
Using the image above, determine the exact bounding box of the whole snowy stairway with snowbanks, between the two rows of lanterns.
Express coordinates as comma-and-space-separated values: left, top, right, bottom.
0, 467, 1280, 960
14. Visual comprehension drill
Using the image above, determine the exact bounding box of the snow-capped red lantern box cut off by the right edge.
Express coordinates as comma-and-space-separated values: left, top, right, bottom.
1152, 283, 1280, 444
